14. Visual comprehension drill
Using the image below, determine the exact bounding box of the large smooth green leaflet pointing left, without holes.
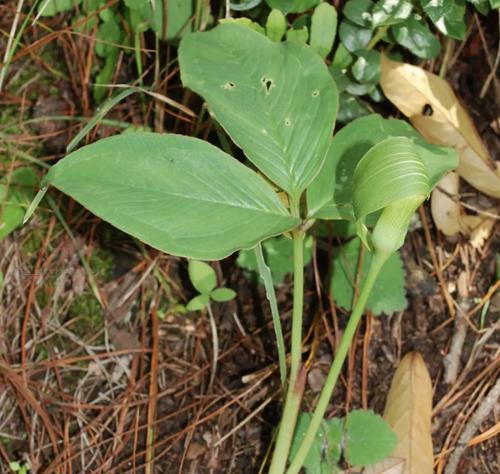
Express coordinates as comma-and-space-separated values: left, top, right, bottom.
44, 133, 297, 260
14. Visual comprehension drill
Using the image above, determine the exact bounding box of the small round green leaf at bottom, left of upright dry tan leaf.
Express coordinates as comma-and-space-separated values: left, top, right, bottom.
344, 410, 398, 466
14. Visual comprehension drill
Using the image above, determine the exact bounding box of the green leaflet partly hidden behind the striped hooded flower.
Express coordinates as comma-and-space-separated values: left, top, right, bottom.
307, 114, 458, 219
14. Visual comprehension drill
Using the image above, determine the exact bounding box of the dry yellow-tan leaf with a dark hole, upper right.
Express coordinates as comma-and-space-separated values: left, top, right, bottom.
380, 55, 500, 198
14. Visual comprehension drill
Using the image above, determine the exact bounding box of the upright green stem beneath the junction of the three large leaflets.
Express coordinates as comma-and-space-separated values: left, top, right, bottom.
269, 228, 305, 474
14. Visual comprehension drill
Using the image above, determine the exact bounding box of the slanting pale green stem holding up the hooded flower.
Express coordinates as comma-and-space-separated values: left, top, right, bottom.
287, 252, 390, 474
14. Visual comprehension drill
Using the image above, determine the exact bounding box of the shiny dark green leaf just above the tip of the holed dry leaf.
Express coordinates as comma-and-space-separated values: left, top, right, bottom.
391, 16, 441, 59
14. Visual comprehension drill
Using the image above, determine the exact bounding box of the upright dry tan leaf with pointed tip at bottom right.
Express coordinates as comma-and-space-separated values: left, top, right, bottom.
384, 352, 433, 474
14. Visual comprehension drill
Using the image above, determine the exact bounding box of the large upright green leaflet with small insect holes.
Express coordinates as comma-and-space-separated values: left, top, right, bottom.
179, 24, 338, 198
